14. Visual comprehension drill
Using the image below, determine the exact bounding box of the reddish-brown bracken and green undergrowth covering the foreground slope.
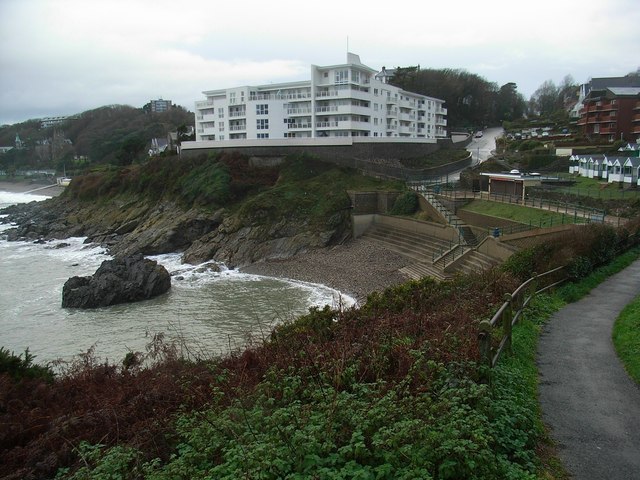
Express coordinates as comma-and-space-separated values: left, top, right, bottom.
5, 216, 640, 480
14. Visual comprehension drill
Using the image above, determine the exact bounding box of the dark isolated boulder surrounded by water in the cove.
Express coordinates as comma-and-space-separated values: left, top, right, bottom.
62, 254, 171, 308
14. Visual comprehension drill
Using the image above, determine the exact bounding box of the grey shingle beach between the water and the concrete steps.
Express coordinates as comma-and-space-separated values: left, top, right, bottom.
241, 239, 410, 303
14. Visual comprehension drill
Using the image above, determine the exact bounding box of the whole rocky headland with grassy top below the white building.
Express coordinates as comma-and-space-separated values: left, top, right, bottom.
5, 154, 397, 267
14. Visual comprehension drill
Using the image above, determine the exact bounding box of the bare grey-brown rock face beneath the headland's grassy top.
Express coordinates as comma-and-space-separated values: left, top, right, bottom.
0, 187, 351, 267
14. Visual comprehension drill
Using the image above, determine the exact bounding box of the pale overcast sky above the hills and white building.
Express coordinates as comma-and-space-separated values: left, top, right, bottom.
0, 0, 640, 125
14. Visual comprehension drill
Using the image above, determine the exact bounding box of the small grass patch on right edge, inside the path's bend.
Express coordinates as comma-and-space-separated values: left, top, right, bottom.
612, 296, 640, 384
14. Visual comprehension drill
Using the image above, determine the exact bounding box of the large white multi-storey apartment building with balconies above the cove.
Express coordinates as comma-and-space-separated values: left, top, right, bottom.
195, 53, 447, 146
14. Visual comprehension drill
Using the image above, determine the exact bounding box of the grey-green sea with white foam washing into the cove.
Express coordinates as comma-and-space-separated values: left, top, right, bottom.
0, 190, 355, 365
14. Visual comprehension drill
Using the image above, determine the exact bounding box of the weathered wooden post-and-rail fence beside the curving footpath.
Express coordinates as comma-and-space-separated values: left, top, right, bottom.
478, 267, 568, 382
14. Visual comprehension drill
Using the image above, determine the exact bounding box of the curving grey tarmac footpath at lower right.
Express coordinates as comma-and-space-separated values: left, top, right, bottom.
538, 260, 640, 480
